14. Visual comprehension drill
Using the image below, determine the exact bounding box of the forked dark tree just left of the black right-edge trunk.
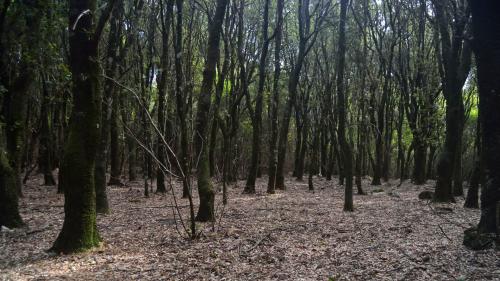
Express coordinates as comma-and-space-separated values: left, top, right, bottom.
432, 0, 472, 202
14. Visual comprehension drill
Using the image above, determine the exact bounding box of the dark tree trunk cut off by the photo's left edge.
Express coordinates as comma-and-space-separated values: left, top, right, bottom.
0, 1, 47, 227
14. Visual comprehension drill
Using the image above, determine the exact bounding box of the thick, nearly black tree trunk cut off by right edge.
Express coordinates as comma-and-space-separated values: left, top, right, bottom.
469, 1, 500, 235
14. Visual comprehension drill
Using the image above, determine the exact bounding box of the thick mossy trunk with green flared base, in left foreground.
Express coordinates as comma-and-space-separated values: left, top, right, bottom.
51, 0, 114, 253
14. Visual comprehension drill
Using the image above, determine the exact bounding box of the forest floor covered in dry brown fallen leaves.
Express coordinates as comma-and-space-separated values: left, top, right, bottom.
0, 174, 500, 280
